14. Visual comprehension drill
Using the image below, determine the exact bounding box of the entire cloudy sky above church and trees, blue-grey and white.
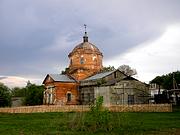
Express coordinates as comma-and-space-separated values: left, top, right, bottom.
0, 0, 180, 87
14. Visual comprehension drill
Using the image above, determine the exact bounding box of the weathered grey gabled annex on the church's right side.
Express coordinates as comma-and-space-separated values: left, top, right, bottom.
79, 70, 150, 106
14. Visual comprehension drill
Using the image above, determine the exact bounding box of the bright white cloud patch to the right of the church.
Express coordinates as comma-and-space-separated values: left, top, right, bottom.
105, 24, 180, 82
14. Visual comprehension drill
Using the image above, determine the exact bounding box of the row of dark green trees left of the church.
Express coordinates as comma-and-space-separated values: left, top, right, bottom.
0, 81, 44, 107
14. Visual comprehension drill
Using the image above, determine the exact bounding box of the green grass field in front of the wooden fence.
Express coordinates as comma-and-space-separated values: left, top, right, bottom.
0, 107, 180, 135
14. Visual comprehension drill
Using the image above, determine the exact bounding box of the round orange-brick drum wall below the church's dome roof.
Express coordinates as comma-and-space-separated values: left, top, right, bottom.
69, 49, 103, 80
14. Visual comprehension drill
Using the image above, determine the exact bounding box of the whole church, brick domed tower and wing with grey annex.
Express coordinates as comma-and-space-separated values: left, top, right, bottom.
43, 31, 149, 105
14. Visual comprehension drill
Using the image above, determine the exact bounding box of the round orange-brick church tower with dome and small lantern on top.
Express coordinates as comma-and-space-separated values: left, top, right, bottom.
68, 29, 103, 80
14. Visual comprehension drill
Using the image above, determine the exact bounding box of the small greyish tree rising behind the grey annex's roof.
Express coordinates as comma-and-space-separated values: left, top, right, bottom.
118, 65, 137, 76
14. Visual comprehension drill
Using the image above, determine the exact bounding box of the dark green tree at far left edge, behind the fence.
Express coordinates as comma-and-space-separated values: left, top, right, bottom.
0, 83, 11, 107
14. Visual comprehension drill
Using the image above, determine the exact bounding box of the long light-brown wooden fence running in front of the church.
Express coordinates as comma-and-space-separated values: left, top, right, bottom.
0, 104, 172, 113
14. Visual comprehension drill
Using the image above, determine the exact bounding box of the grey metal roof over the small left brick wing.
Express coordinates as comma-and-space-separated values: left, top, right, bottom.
49, 74, 76, 82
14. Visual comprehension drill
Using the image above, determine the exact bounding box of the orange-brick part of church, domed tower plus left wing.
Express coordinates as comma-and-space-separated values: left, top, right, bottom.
43, 31, 103, 105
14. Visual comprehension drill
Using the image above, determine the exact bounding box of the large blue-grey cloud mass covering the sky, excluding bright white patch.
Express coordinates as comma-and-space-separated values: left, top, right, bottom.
0, 0, 180, 87
